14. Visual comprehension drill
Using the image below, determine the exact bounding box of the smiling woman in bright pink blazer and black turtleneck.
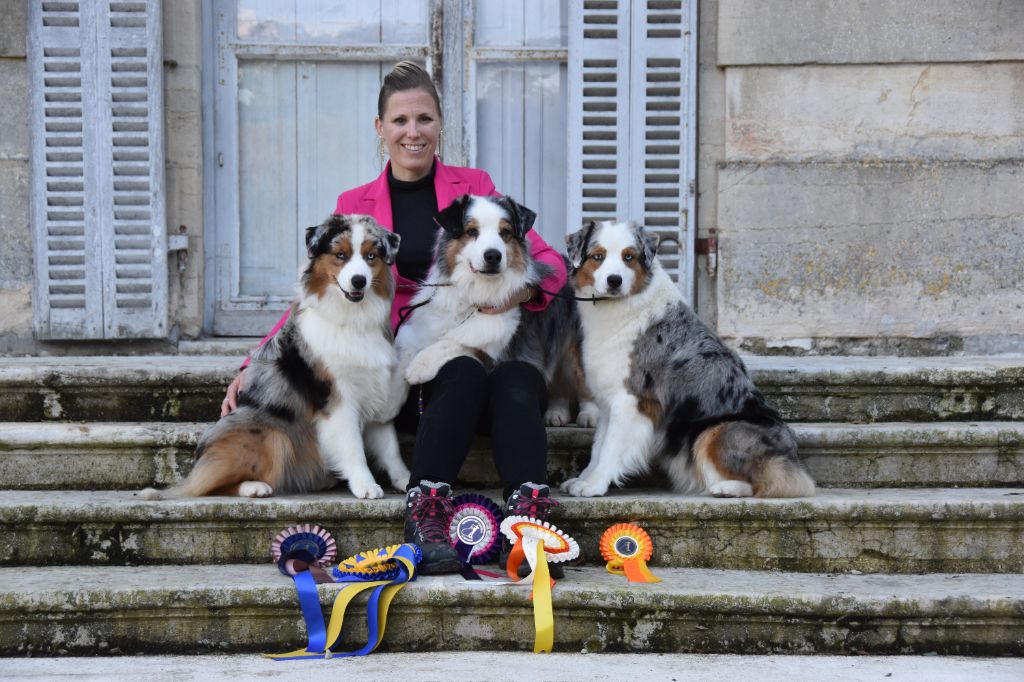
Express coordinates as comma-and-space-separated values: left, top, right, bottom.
221, 61, 565, 578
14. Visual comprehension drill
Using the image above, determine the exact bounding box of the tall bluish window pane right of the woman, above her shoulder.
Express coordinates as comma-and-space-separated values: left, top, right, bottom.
476, 62, 568, 250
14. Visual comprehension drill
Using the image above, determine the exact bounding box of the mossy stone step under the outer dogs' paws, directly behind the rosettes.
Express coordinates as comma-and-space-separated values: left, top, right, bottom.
0, 488, 1024, 573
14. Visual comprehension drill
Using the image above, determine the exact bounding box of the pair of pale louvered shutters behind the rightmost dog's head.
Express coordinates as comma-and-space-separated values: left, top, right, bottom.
568, 0, 696, 300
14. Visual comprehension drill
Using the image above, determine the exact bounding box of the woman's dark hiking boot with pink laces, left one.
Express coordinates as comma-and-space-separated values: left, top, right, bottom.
406, 480, 462, 576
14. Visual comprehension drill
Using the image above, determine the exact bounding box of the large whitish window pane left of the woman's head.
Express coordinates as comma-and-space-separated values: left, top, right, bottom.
238, 60, 392, 297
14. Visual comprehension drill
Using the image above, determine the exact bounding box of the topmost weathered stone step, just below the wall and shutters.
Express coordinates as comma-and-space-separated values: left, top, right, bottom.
0, 355, 1024, 422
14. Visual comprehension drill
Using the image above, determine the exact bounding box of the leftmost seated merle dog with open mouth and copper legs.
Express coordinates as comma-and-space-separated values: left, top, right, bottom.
142, 215, 410, 499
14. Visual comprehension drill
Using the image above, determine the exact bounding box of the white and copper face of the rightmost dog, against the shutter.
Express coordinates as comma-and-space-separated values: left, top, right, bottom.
565, 220, 658, 297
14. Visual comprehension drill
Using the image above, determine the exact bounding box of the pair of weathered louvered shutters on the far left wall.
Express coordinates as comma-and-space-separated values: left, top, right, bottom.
28, 0, 167, 339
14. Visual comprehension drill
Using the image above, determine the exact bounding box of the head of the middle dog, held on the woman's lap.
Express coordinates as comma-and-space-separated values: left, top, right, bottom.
434, 195, 537, 278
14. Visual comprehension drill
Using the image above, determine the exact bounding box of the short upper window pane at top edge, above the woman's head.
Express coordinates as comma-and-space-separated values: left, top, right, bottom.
237, 0, 428, 45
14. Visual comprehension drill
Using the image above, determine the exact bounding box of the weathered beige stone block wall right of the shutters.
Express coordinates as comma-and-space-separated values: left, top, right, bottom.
699, 0, 1024, 353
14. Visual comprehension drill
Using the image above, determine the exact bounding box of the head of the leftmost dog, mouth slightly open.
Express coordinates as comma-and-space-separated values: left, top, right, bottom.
302, 215, 400, 303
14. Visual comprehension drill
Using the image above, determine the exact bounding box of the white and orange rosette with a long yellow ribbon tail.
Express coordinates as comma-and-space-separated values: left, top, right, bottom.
502, 516, 580, 653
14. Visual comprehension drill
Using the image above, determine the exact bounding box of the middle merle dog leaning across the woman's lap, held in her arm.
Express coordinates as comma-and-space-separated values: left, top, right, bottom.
392, 195, 596, 425
